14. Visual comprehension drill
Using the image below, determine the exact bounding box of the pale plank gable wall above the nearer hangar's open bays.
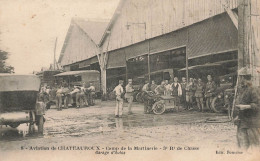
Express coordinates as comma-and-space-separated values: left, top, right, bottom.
103, 0, 238, 51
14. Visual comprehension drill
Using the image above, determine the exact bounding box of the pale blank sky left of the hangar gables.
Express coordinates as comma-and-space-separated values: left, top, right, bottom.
0, 0, 119, 74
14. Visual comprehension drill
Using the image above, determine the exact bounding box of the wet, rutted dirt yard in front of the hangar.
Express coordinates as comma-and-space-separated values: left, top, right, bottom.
0, 101, 258, 160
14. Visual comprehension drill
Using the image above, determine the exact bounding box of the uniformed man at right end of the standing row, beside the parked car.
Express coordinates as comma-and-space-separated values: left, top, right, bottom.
205, 75, 217, 110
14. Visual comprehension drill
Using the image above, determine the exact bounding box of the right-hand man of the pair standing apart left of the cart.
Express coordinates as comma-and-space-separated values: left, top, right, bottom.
125, 79, 134, 114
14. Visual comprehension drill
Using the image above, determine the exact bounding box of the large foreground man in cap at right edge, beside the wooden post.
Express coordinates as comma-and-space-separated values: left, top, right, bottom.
234, 68, 260, 149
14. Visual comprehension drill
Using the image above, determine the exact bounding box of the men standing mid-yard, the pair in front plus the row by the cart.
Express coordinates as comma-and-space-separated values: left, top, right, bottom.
113, 75, 217, 117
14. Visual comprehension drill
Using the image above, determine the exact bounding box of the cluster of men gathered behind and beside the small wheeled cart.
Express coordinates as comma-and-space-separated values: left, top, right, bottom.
142, 75, 217, 113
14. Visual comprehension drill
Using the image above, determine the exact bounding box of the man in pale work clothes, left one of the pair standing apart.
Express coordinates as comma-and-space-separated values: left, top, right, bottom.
113, 80, 124, 117
